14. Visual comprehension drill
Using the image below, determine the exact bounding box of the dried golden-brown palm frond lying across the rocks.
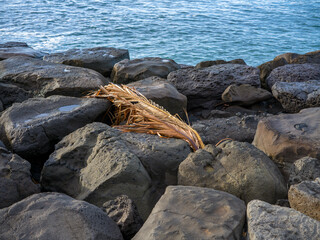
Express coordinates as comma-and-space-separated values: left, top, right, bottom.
88, 83, 204, 151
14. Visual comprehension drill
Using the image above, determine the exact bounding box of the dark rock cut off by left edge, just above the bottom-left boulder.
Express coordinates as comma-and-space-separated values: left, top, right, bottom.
0, 145, 40, 208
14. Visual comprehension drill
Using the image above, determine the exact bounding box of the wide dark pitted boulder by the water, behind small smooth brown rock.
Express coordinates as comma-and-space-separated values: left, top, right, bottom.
168, 64, 260, 110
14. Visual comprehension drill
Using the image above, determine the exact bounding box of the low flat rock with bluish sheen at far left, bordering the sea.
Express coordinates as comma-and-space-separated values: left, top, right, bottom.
0, 42, 45, 61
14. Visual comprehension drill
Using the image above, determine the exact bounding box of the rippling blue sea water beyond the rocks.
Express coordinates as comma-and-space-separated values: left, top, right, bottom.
0, 0, 320, 66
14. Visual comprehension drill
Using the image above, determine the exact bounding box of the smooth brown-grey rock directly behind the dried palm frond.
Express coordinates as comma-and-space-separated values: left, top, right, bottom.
128, 77, 187, 116
